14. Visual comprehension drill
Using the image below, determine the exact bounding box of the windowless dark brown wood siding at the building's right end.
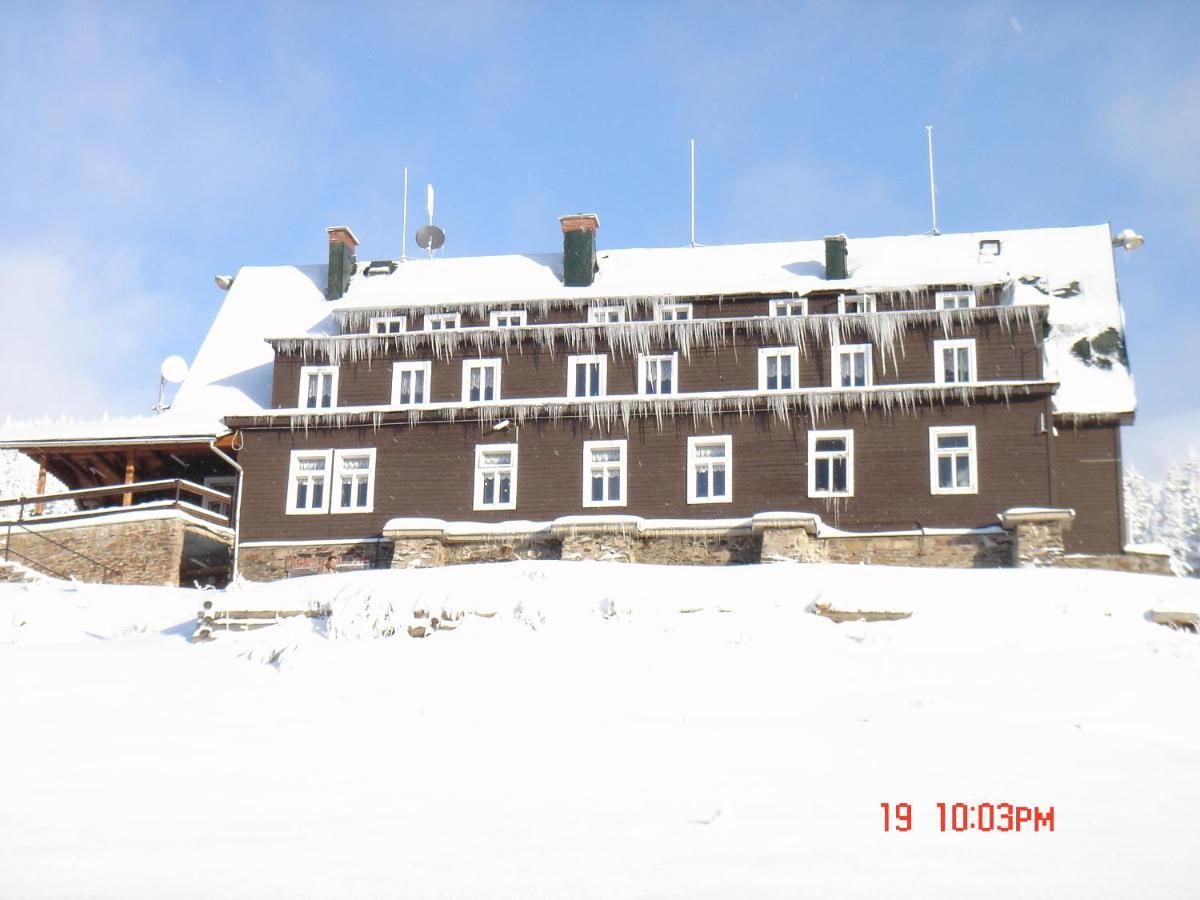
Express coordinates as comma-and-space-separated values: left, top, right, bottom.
1054, 425, 1124, 553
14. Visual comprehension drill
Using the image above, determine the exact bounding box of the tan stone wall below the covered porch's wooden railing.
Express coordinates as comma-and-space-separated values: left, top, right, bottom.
0, 518, 186, 587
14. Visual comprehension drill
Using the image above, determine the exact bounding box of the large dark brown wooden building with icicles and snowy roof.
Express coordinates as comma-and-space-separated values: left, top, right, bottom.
2, 215, 1134, 577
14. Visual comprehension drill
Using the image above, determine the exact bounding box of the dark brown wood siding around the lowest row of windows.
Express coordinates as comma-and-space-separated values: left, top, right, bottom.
231, 398, 1051, 541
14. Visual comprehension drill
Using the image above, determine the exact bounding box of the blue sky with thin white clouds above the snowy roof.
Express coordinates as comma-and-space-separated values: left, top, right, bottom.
0, 1, 1200, 474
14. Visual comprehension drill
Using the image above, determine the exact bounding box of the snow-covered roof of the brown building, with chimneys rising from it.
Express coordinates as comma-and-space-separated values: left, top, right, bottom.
0, 224, 1135, 445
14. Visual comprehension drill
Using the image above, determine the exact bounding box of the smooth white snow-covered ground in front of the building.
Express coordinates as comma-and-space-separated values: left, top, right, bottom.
0, 563, 1200, 899
